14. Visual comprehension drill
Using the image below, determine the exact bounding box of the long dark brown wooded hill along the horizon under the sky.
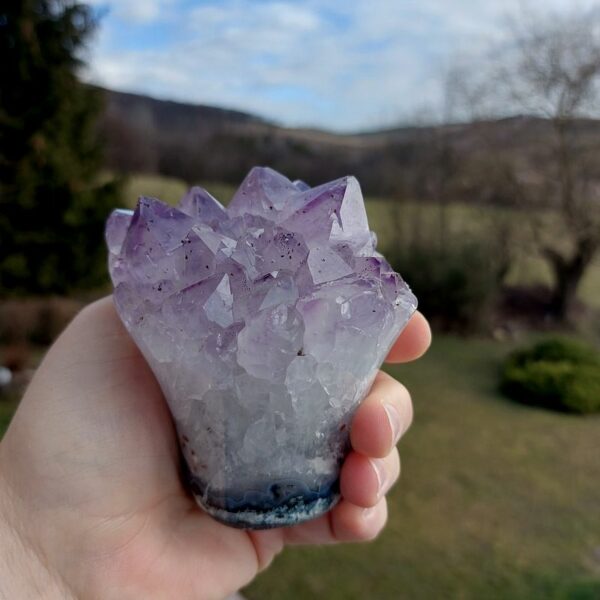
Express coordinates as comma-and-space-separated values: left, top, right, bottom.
101, 90, 600, 195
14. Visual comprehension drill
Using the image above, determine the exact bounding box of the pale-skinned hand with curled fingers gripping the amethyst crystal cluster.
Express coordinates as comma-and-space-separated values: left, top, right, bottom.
0, 298, 431, 600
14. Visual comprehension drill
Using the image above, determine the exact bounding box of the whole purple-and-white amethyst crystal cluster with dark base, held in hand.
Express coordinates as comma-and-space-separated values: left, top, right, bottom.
106, 168, 416, 528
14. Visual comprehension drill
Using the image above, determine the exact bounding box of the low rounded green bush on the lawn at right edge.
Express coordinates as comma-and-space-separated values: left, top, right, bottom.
501, 338, 600, 414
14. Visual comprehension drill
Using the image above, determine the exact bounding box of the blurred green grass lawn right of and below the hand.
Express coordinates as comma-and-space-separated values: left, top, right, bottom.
245, 337, 600, 600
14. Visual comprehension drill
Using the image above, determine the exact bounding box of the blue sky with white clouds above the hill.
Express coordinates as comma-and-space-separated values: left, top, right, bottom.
85, 0, 600, 132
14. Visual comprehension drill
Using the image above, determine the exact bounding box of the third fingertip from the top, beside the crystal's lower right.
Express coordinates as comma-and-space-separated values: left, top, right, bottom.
340, 448, 400, 508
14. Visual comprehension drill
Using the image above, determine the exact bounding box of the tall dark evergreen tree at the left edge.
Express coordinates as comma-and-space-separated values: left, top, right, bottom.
0, 0, 120, 294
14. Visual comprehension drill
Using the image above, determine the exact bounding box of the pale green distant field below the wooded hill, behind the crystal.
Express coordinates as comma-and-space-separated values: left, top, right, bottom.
126, 175, 600, 309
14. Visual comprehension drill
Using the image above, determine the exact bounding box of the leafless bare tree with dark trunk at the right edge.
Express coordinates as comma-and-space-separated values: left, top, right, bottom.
454, 9, 600, 321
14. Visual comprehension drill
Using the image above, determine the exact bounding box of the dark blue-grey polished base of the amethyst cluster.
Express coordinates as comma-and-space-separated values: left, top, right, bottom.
190, 477, 340, 529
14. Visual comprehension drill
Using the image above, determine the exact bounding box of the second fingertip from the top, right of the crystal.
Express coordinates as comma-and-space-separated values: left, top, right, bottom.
350, 372, 413, 458
